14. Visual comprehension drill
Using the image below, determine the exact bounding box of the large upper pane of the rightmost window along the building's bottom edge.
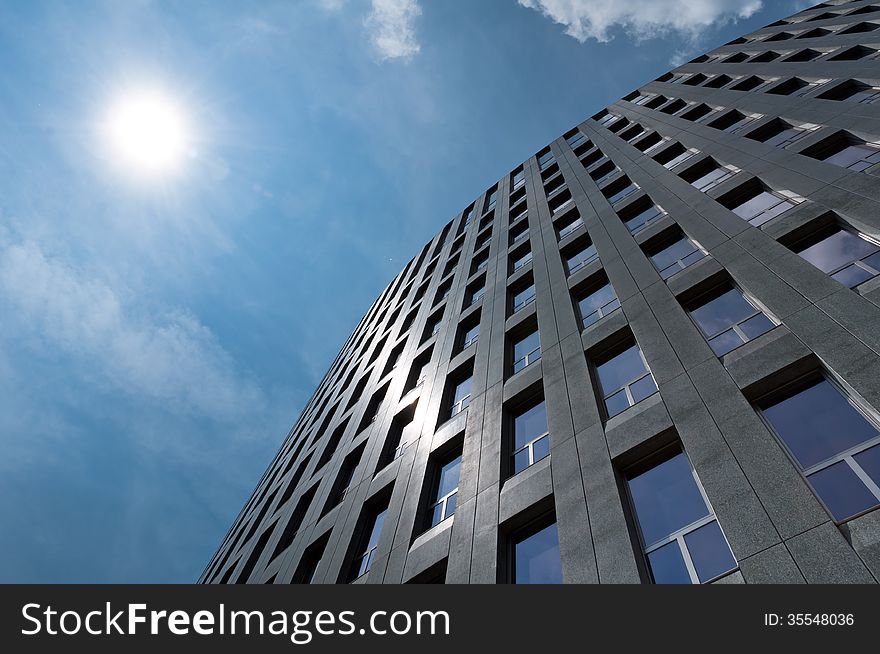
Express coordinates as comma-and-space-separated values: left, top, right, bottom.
629, 452, 709, 546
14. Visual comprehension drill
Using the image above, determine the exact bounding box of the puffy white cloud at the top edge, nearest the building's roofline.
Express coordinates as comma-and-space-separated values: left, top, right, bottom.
517, 0, 762, 42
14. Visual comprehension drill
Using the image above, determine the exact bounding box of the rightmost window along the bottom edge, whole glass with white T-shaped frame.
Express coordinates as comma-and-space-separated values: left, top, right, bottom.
627, 451, 736, 584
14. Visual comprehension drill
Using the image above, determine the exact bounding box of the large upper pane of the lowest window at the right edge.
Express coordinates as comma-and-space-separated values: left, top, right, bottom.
764, 379, 877, 469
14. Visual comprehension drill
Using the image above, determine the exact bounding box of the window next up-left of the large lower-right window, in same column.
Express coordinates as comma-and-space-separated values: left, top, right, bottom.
689, 287, 776, 356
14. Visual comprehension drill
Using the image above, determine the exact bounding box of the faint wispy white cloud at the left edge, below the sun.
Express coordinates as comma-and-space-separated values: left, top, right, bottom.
0, 240, 264, 419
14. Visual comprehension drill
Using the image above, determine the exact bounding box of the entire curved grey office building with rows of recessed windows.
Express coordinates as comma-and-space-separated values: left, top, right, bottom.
201, 0, 880, 583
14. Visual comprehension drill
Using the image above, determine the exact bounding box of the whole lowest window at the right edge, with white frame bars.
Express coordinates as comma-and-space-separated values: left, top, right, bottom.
762, 377, 880, 522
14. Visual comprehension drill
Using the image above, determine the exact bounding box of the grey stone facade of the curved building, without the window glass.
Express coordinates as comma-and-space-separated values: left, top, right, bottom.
200, 0, 880, 583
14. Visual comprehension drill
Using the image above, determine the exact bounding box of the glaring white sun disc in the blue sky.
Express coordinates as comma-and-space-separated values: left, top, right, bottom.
105, 90, 189, 176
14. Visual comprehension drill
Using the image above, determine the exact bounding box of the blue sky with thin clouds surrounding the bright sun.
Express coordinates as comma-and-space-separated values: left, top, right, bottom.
0, 0, 805, 582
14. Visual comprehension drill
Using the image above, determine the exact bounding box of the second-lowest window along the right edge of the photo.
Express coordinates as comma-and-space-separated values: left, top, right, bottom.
793, 225, 880, 288
